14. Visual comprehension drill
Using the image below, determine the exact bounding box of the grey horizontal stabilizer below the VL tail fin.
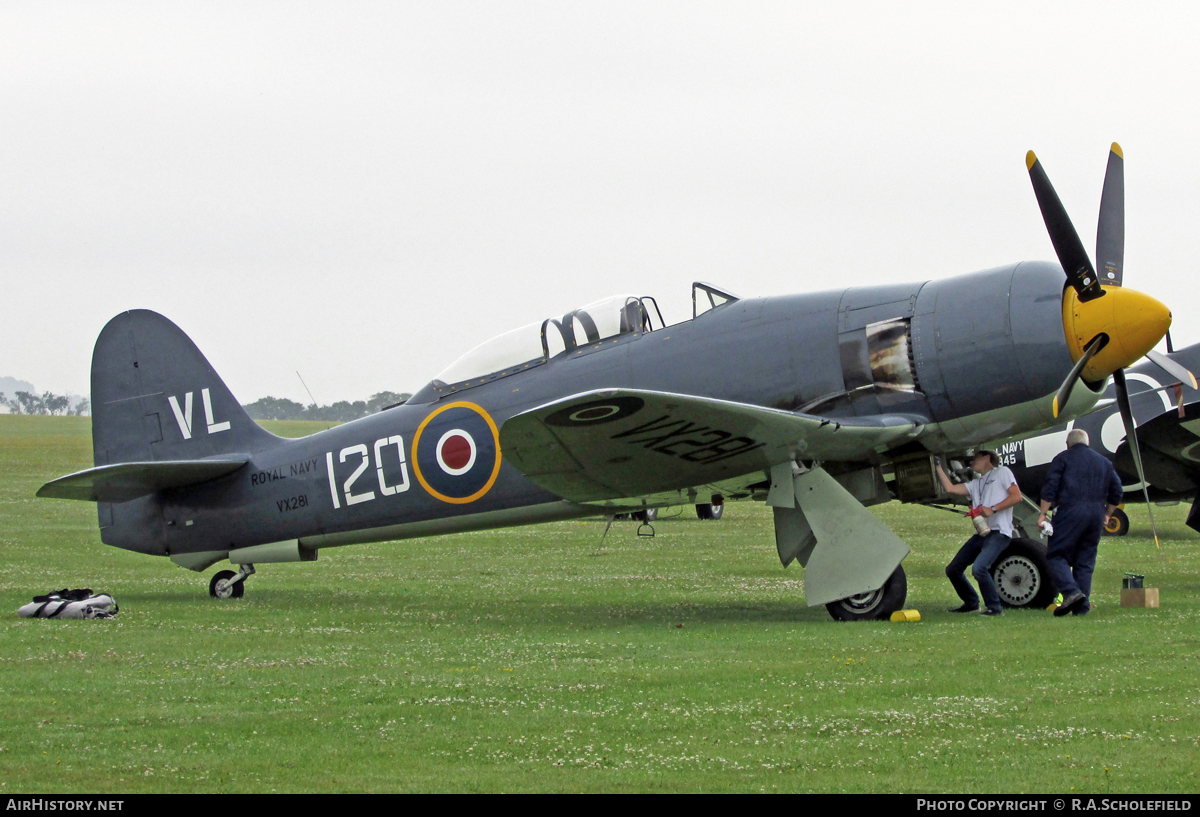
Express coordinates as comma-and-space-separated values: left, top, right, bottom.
37, 455, 250, 503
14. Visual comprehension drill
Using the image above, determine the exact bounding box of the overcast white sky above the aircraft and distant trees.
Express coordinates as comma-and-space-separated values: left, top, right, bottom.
0, 0, 1200, 403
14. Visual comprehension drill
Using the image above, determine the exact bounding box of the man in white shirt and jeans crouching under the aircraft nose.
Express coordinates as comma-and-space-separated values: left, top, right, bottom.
937, 451, 1021, 615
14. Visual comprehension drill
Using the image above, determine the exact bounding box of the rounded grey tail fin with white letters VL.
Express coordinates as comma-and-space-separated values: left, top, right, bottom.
91, 310, 282, 467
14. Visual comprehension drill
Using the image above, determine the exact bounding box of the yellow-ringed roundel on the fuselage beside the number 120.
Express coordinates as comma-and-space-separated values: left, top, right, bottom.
413, 402, 500, 505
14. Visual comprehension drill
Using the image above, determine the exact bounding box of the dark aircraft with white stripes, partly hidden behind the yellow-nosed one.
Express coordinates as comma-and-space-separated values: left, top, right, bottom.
997, 344, 1200, 536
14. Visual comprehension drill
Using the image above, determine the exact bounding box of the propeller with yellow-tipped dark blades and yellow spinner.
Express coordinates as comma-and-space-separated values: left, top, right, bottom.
1025, 142, 1196, 545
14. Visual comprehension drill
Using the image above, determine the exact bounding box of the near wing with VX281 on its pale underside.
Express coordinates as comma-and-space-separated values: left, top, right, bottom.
500, 389, 928, 503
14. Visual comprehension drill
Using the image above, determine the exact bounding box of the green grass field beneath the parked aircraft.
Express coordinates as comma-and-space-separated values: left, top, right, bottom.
0, 415, 1200, 793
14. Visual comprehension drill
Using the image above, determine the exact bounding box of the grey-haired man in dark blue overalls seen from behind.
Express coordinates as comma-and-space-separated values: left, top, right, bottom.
1038, 428, 1122, 615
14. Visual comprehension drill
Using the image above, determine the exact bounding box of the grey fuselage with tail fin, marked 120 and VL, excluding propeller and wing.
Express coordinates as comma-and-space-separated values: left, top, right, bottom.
92, 262, 1084, 570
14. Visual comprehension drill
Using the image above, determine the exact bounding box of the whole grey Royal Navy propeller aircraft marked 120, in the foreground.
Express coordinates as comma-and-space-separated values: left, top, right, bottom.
38, 144, 1190, 619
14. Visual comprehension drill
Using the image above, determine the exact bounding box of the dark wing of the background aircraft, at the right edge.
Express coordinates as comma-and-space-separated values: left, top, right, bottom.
1114, 403, 1200, 493
